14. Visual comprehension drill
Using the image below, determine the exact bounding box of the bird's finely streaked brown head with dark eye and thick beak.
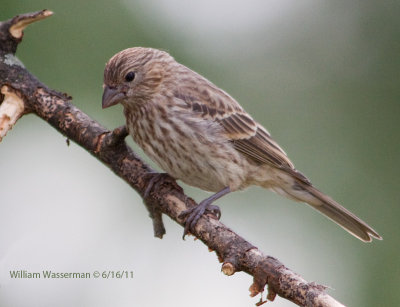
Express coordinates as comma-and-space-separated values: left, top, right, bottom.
102, 47, 175, 109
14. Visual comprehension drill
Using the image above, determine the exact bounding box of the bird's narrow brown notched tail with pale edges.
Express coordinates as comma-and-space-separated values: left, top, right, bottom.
272, 180, 382, 242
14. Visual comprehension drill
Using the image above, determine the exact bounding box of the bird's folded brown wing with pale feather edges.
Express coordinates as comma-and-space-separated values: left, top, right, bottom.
175, 83, 310, 184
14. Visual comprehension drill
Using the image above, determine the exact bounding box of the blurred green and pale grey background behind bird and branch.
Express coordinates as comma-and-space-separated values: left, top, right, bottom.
0, 0, 400, 307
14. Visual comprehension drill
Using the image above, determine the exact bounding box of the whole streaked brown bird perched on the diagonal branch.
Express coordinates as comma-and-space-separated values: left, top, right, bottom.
102, 47, 382, 242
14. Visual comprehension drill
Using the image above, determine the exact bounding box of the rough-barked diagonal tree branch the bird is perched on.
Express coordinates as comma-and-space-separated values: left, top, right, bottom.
0, 10, 343, 306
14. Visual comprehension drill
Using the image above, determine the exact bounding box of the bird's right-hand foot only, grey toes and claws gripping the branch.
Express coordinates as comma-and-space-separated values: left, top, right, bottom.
179, 198, 221, 239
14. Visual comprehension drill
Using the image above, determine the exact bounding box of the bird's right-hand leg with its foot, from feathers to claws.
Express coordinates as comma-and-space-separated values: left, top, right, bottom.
179, 187, 231, 238
